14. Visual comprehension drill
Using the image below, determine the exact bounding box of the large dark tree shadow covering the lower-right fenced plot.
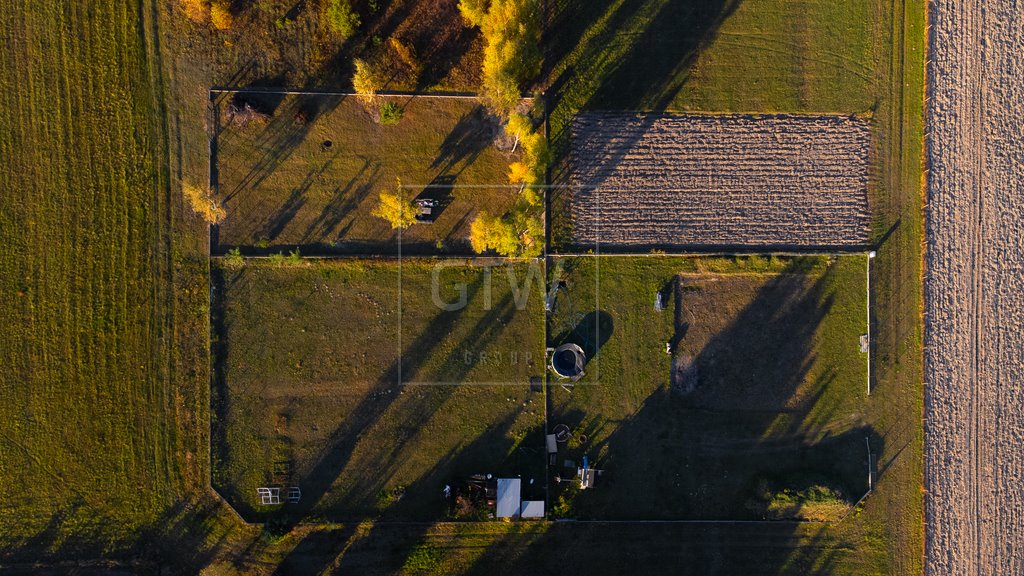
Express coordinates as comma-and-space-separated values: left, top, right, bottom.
549, 261, 885, 520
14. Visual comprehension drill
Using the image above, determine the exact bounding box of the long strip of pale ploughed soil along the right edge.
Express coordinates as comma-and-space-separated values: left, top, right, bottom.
925, 0, 1024, 575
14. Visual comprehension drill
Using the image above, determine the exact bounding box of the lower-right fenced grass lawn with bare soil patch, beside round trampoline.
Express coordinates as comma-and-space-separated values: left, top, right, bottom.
550, 256, 880, 520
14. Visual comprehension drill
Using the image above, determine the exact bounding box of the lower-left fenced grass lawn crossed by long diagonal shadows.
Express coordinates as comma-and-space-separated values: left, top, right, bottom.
213, 259, 545, 520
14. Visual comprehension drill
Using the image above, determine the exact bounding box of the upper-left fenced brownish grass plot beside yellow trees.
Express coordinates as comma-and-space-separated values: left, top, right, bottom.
215, 94, 519, 254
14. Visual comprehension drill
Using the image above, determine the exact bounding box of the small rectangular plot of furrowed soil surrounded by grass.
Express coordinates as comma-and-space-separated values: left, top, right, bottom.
569, 114, 870, 247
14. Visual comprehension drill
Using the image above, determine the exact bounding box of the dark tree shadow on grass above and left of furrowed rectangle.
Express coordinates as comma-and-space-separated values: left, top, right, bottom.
544, 0, 740, 247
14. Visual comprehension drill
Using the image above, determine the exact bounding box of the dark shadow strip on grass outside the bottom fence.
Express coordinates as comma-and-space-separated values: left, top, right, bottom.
458, 516, 856, 576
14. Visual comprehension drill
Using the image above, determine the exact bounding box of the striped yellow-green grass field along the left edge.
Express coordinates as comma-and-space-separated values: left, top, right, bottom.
0, 2, 178, 561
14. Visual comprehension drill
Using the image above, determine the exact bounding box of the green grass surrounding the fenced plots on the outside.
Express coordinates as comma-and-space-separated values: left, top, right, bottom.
0, 0, 926, 575
